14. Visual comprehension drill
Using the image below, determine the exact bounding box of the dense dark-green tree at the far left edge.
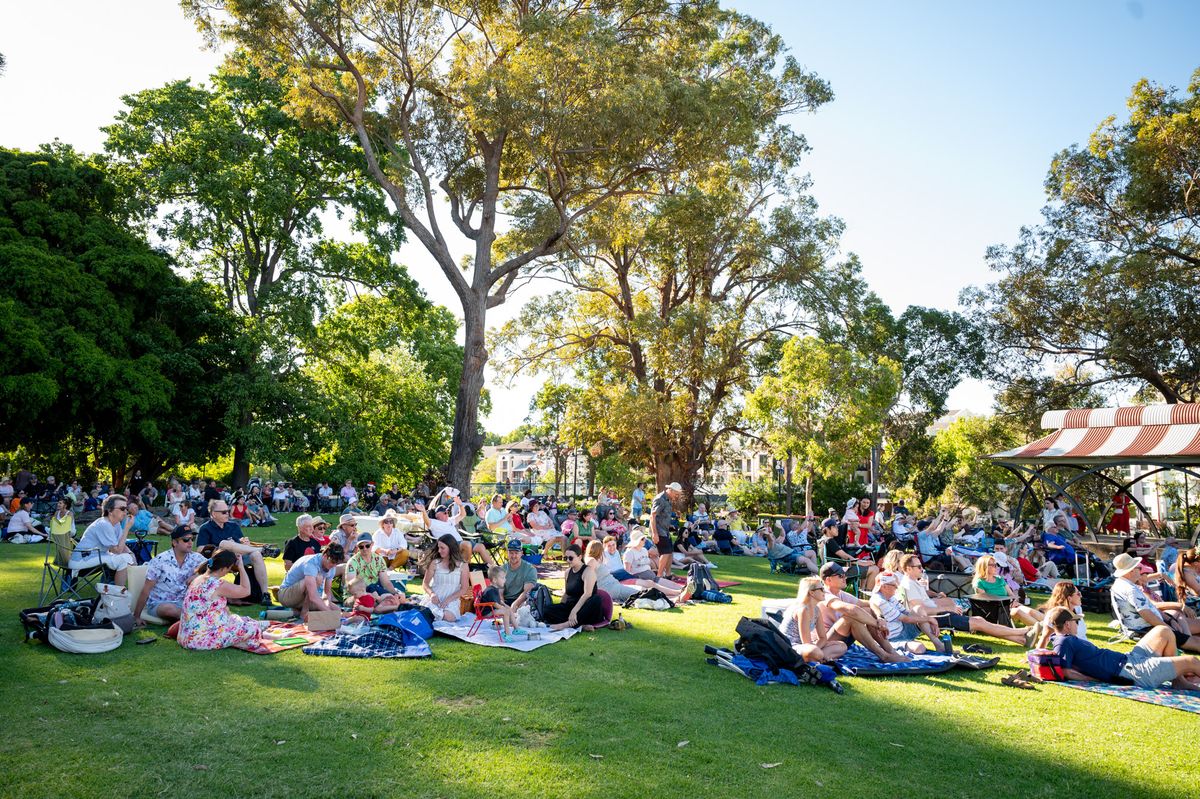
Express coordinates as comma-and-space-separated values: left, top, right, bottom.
0, 148, 250, 485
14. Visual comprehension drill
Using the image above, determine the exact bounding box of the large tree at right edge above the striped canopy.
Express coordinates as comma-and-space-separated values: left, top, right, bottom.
964, 71, 1200, 407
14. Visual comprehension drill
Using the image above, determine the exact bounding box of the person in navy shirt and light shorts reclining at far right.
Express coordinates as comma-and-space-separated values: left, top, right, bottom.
1046, 607, 1200, 691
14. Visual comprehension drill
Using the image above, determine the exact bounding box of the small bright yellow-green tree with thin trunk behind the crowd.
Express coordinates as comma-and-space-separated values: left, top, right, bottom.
745, 336, 900, 513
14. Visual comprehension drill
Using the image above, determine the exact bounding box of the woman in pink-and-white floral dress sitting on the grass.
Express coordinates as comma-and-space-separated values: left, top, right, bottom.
179, 549, 268, 649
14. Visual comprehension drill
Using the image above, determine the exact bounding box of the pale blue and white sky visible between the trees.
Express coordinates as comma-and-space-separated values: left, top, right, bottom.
0, 0, 1200, 433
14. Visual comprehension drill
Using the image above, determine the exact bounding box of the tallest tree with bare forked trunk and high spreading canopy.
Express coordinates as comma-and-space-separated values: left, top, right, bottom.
184, 0, 828, 488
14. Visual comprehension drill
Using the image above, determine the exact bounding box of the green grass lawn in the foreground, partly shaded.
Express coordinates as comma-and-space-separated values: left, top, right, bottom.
0, 515, 1198, 799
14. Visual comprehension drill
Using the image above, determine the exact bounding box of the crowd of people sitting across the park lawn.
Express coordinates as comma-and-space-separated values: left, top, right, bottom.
11, 460, 1200, 686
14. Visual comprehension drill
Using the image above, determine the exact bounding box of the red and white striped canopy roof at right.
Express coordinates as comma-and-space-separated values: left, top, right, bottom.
990, 403, 1200, 463
